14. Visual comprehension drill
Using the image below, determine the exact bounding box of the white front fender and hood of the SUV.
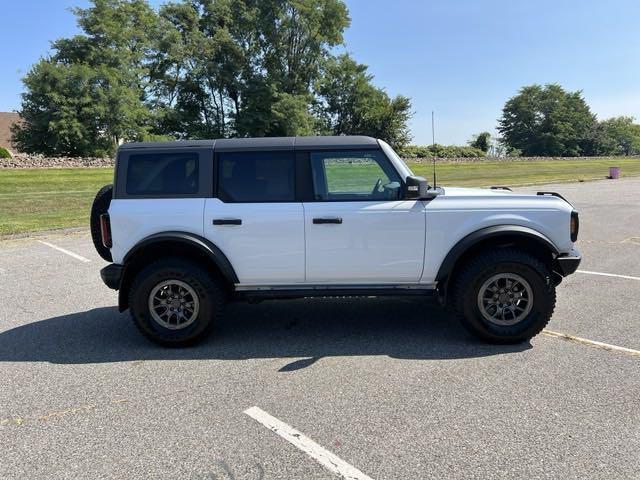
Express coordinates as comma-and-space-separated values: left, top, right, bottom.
422, 187, 573, 283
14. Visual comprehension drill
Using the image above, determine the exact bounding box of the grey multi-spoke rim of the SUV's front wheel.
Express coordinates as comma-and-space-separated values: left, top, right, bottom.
478, 273, 533, 325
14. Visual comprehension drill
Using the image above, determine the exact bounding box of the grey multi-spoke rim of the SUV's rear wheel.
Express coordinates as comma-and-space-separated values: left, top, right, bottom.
149, 280, 200, 330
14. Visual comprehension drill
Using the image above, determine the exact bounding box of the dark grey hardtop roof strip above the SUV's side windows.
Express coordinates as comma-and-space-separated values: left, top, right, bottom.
120, 135, 378, 152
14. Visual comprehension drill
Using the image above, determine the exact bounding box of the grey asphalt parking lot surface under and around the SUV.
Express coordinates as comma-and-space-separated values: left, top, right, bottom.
0, 179, 640, 480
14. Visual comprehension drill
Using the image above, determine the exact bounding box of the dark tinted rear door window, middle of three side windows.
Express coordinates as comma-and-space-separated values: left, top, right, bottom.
218, 152, 295, 202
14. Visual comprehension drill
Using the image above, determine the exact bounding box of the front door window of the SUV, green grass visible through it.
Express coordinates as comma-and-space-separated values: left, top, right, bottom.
311, 150, 400, 201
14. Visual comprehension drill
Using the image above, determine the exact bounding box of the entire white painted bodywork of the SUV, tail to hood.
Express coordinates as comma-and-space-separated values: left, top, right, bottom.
109, 141, 573, 287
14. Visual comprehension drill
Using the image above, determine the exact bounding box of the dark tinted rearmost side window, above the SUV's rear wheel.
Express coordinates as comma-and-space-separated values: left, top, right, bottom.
127, 152, 198, 195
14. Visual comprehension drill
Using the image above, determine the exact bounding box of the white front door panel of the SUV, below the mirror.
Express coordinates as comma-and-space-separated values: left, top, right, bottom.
304, 201, 425, 284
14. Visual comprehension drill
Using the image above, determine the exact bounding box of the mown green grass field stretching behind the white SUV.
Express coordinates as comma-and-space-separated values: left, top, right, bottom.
0, 158, 640, 235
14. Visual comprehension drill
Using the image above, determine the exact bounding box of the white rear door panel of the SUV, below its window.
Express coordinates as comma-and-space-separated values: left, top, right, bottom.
204, 198, 304, 285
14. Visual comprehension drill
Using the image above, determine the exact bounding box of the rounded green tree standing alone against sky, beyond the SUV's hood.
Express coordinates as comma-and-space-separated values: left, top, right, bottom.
498, 84, 596, 156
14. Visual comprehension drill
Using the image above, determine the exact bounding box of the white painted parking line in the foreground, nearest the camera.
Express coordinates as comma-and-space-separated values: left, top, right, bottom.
244, 407, 372, 480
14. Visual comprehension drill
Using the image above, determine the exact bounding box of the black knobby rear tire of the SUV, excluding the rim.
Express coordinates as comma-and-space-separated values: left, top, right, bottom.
129, 258, 225, 347
